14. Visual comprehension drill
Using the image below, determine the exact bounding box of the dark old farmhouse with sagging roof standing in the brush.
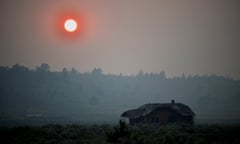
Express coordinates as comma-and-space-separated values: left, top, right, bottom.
121, 100, 195, 125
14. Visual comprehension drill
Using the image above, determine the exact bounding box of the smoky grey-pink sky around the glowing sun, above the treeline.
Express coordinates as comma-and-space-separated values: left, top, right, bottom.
0, 0, 240, 79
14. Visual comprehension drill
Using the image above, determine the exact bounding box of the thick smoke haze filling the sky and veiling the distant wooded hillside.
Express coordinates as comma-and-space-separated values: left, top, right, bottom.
0, 0, 240, 125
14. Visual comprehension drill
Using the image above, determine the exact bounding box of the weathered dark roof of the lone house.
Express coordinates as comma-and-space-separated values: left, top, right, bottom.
121, 103, 195, 118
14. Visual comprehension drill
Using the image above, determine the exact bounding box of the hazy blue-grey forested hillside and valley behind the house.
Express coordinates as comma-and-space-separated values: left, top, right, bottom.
0, 64, 240, 125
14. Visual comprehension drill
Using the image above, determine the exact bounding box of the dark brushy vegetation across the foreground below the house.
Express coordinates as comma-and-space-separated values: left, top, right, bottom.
0, 122, 240, 144
